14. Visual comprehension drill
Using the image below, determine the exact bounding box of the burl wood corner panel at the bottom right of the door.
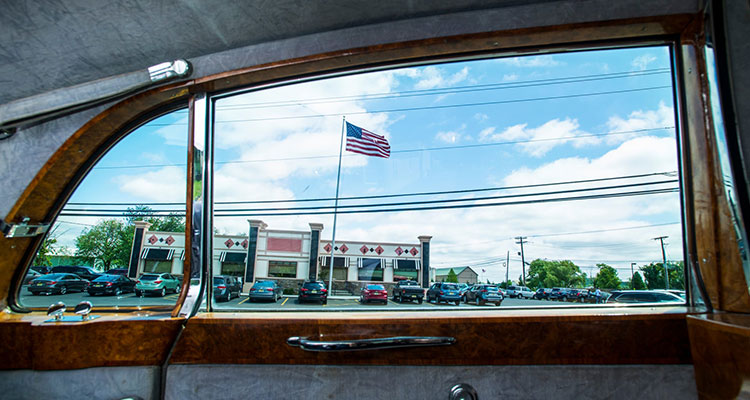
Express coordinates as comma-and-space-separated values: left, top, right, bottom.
687, 314, 750, 400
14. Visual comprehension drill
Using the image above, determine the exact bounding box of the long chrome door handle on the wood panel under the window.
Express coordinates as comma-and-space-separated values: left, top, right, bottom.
286, 336, 456, 351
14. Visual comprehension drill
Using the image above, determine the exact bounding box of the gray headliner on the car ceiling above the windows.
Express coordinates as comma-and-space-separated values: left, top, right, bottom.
0, 0, 698, 105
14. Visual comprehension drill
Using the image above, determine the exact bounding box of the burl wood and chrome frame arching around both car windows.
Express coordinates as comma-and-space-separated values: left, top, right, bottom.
8, 16, 740, 316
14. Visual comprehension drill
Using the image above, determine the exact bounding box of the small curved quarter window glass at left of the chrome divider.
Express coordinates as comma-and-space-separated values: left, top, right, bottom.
18, 110, 187, 309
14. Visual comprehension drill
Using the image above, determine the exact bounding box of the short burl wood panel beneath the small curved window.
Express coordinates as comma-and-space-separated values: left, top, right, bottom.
0, 313, 182, 372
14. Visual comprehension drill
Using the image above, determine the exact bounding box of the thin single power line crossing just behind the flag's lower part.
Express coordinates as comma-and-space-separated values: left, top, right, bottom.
88, 126, 674, 170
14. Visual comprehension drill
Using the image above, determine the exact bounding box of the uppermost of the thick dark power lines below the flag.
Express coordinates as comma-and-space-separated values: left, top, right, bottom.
67, 171, 676, 206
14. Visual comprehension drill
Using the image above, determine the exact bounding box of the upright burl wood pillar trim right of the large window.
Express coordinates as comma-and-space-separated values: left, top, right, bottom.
680, 20, 750, 312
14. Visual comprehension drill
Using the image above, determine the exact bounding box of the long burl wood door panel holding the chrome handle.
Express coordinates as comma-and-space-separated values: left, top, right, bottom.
171, 313, 691, 365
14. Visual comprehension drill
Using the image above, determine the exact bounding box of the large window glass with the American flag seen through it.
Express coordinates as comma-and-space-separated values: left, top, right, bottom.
213, 46, 685, 311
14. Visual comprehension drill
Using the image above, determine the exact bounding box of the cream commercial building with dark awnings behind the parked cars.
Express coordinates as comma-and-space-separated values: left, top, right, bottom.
128, 220, 432, 291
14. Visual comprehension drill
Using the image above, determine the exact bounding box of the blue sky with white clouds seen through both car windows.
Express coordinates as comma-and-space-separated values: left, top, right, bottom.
60, 47, 682, 280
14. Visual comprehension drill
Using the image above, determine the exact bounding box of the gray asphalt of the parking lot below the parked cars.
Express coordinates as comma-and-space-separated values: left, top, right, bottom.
19, 287, 570, 311
